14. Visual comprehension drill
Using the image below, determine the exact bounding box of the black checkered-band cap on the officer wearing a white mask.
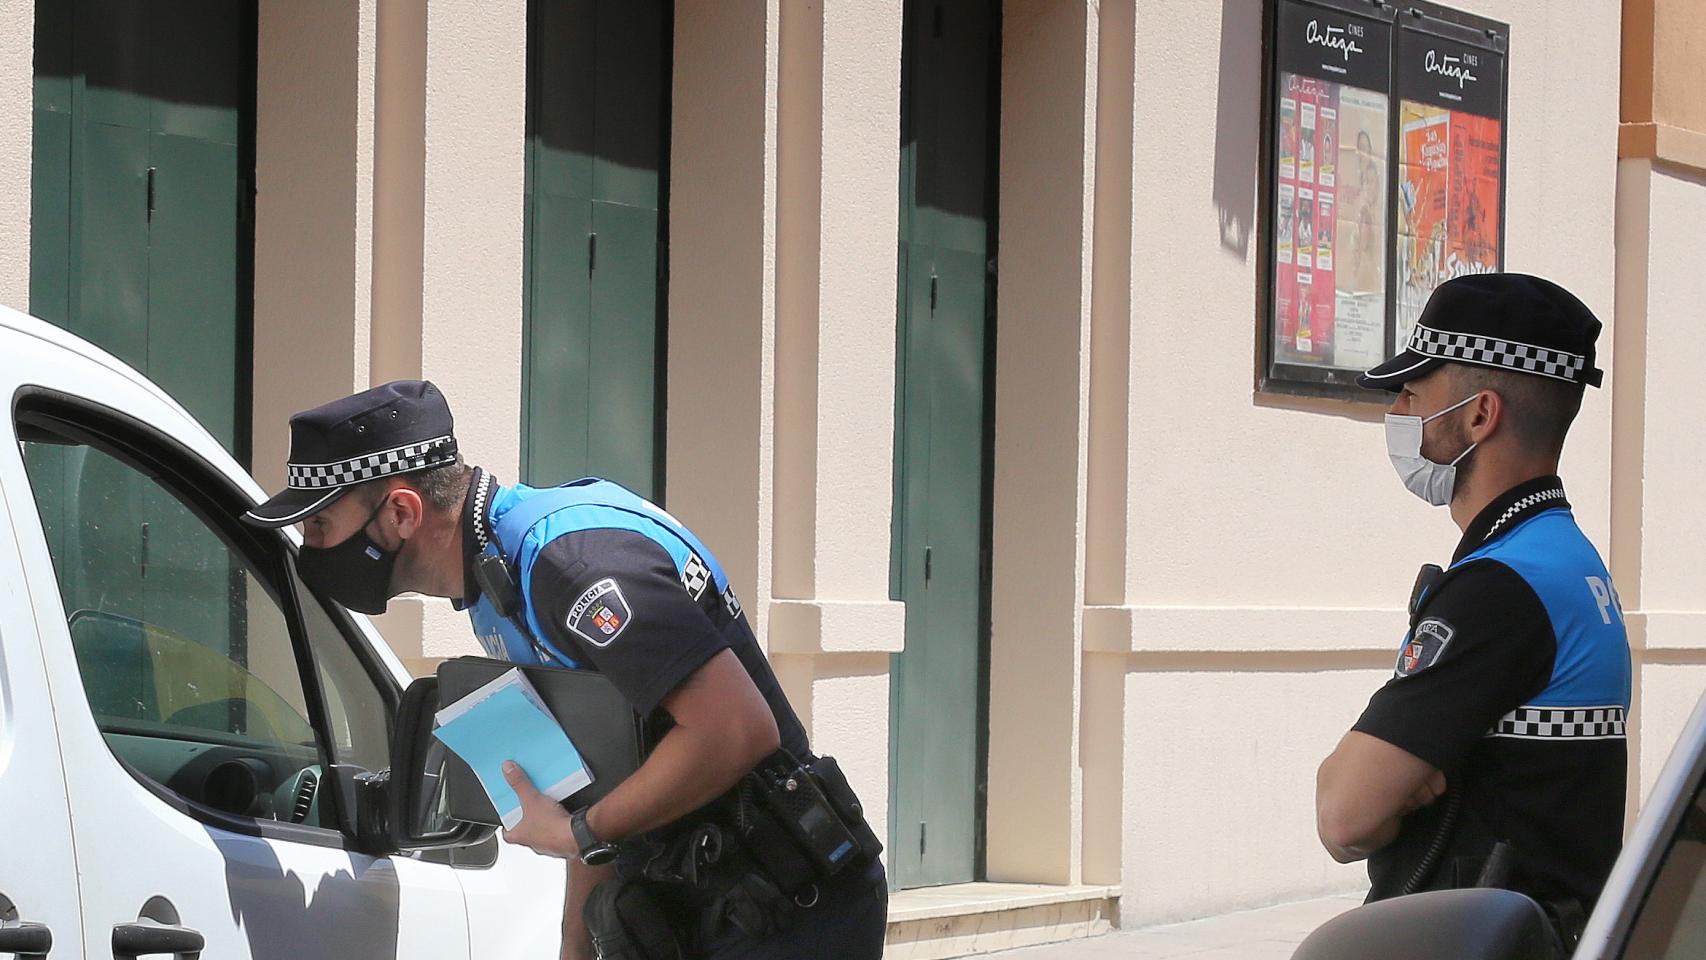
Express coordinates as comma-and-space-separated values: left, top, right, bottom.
1356, 273, 1604, 392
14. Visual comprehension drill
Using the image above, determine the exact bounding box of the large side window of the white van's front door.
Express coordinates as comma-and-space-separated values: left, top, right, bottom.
20, 433, 336, 827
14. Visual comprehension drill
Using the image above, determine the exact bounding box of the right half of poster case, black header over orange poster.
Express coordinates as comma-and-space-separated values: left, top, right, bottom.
1394, 29, 1505, 348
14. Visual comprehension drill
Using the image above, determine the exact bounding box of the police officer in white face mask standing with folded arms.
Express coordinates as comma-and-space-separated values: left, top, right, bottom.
1315, 275, 1629, 940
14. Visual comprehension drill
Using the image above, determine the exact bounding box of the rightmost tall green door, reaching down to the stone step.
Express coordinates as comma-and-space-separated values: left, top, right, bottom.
889, 0, 998, 887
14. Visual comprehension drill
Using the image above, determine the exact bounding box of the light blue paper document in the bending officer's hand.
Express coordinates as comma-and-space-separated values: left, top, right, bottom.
433, 670, 592, 830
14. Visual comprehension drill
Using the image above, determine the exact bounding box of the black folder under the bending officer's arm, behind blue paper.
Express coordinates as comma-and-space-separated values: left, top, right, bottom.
438, 656, 645, 825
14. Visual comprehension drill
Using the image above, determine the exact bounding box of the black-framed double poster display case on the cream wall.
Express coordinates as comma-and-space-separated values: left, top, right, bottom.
1257, 0, 1506, 401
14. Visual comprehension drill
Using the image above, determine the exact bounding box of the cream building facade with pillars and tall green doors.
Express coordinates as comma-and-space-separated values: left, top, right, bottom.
0, 0, 1706, 957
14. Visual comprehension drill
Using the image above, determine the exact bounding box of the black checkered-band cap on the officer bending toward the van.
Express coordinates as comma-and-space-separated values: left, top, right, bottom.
244, 380, 456, 527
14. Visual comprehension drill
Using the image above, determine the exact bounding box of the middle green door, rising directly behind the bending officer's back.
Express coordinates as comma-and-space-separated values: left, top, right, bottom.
522, 0, 670, 500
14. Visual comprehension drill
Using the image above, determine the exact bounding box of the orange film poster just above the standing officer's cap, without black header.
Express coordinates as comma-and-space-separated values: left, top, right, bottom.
1397, 101, 1501, 344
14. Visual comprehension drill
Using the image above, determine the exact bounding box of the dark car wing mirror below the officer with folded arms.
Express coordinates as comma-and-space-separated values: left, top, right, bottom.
1291, 888, 1564, 960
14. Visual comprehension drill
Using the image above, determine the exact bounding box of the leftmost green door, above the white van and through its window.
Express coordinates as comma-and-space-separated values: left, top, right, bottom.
29, 0, 254, 675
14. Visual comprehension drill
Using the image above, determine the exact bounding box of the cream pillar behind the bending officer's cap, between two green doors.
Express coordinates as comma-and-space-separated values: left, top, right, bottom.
374, 0, 527, 670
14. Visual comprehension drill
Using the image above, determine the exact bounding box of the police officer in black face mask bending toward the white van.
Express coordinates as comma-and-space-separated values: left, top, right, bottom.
246, 380, 887, 960
